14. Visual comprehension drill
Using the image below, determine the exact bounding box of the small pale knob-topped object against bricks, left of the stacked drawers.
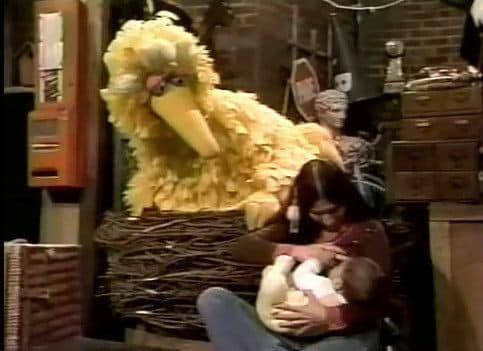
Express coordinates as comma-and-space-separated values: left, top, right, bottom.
384, 40, 404, 94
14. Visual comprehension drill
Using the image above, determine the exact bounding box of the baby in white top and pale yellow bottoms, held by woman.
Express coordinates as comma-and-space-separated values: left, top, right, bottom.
256, 255, 383, 333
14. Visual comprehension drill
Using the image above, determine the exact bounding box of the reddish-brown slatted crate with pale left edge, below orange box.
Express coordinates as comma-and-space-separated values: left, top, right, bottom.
4, 243, 82, 351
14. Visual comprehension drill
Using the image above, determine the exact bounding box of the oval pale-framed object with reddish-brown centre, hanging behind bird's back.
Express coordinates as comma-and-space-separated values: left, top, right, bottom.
290, 58, 320, 122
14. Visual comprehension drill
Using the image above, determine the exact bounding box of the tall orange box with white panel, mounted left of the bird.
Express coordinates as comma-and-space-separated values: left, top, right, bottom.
28, 0, 87, 188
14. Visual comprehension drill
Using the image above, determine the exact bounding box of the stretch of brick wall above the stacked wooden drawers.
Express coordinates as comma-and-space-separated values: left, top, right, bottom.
361, 0, 465, 77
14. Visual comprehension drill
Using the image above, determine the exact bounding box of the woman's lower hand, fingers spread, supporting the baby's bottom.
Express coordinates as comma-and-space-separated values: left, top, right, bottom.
272, 292, 328, 337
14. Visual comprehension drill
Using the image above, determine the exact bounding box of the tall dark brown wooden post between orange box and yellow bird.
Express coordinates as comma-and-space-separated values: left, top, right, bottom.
79, 0, 111, 336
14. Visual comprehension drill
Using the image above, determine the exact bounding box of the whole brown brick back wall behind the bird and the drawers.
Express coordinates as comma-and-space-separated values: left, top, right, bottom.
177, 0, 465, 114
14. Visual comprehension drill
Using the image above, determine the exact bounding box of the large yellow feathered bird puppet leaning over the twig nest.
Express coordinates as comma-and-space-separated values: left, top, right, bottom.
101, 13, 342, 229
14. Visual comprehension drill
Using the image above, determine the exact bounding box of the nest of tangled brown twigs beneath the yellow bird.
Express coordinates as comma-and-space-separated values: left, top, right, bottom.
96, 210, 260, 333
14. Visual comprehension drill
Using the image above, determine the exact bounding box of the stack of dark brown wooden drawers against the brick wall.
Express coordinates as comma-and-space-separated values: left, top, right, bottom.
387, 85, 483, 202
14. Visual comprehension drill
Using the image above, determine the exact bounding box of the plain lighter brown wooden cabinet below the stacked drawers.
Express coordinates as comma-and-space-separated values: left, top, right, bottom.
429, 203, 483, 351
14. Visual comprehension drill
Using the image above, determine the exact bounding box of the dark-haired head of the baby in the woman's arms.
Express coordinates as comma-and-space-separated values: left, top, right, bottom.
329, 257, 384, 302
